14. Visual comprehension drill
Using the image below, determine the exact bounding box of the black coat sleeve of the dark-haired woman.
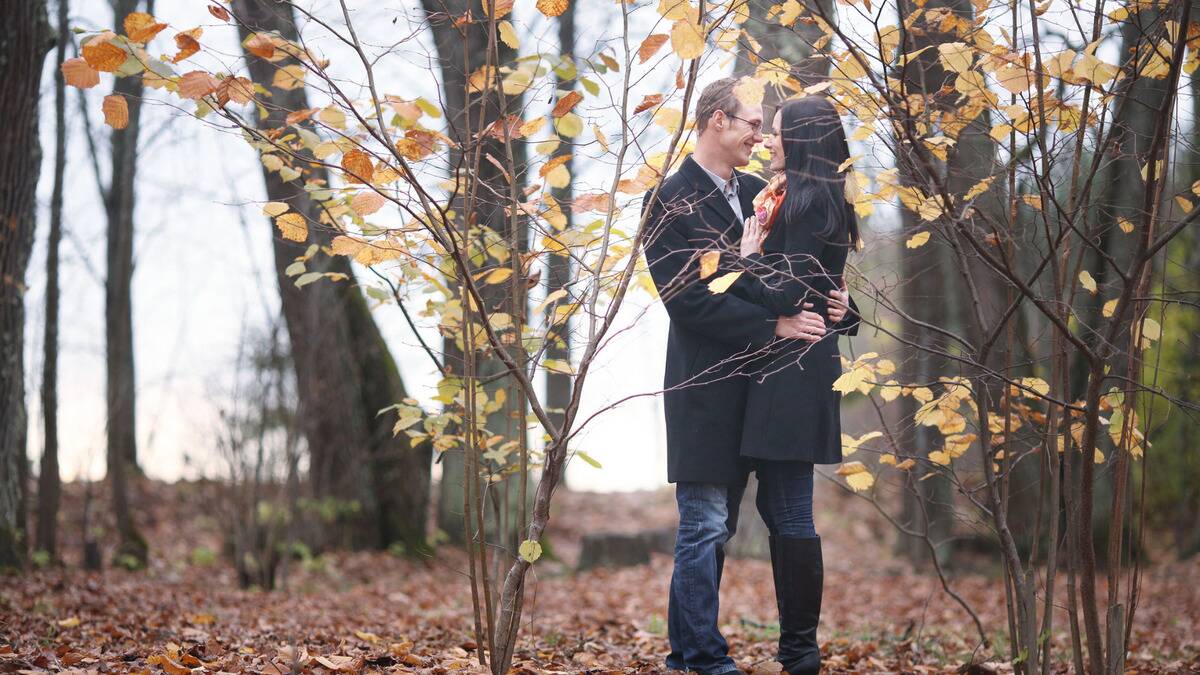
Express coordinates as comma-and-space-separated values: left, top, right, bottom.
739, 205, 827, 316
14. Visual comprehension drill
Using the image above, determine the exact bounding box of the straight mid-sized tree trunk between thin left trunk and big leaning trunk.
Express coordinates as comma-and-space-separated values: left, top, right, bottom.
104, 0, 152, 567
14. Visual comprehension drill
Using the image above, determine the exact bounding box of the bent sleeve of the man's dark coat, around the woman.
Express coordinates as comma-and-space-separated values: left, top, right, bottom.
642, 187, 778, 348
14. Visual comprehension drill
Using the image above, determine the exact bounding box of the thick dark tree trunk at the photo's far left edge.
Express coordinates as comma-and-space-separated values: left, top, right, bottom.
0, 1, 54, 569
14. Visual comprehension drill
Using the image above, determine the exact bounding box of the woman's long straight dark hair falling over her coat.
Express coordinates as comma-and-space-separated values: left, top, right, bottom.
779, 96, 858, 246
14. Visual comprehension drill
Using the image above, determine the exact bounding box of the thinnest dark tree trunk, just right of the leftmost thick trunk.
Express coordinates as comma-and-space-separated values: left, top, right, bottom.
36, 0, 71, 560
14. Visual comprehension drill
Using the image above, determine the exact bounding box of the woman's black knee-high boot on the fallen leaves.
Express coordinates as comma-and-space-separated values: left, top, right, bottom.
773, 537, 824, 675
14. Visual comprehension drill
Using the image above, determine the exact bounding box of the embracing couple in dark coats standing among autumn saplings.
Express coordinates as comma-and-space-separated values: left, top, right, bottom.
644, 78, 858, 675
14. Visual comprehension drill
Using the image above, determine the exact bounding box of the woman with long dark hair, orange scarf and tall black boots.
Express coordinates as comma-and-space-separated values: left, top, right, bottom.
742, 96, 858, 675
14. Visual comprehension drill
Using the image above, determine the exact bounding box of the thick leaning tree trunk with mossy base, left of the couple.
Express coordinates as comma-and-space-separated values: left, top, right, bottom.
233, 0, 432, 551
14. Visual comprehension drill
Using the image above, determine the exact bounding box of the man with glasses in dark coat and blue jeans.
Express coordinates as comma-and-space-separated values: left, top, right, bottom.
643, 78, 847, 675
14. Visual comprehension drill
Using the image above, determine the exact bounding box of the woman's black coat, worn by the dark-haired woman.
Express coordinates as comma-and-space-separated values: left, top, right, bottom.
738, 195, 859, 464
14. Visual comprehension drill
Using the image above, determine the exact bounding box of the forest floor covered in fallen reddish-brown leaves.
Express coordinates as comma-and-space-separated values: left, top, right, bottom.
0, 475, 1200, 674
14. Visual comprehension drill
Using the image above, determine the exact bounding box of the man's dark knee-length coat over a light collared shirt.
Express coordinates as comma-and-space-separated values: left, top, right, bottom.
643, 156, 779, 484
